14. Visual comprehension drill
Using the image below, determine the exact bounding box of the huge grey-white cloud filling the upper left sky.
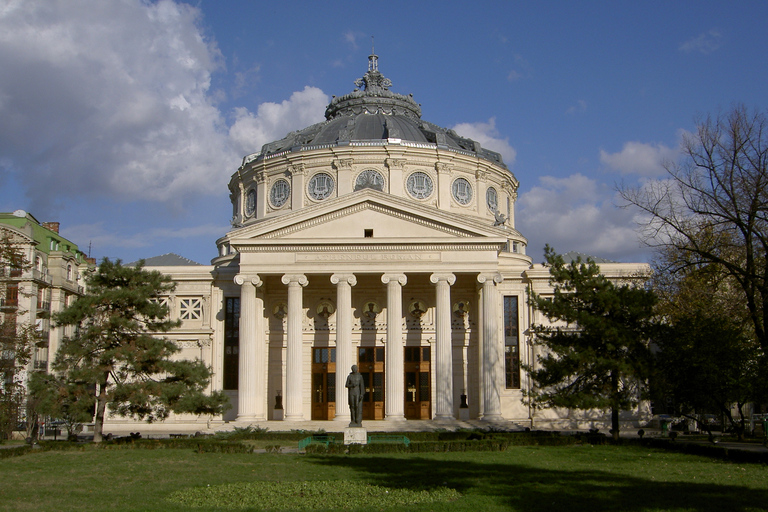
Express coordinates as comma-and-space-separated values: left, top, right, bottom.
0, 0, 238, 212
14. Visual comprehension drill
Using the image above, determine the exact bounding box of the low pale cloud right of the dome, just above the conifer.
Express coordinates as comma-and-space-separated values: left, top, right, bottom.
515, 174, 640, 262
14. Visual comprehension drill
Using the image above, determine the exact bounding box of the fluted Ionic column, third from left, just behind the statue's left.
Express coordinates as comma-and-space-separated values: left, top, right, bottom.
331, 274, 357, 422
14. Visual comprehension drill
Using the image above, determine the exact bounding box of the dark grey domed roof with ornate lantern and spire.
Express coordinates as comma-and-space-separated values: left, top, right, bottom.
248, 53, 506, 168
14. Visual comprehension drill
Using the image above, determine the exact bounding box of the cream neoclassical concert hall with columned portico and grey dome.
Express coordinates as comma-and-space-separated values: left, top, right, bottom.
135, 55, 643, 426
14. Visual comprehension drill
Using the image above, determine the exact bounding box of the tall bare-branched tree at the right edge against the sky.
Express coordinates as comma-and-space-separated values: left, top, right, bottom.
620, 105, 768, 351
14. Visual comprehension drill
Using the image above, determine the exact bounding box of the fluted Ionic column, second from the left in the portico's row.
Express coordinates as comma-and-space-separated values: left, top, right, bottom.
282, 274, 309, 421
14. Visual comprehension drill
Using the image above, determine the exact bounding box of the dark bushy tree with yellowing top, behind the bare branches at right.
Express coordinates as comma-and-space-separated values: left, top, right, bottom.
652, 247, 765, 437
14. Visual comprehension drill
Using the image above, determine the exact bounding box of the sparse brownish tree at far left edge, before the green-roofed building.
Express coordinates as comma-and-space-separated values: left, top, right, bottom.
0, 233, 38, 439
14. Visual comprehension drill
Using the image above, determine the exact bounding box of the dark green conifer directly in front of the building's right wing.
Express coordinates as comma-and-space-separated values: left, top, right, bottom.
526, 246, 656, 439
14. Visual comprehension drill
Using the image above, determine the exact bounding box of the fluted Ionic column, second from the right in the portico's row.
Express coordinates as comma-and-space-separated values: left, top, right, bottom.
429, 274, 456, 419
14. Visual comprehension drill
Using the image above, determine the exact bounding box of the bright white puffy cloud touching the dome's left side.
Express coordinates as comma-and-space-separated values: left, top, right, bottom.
229, 86, 330, 154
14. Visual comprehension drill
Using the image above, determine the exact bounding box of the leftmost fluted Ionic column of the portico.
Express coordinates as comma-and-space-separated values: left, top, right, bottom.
235, 274, 267, 421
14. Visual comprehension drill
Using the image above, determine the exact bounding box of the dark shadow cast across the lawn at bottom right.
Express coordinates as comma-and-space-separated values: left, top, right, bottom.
311, 456, 768, 512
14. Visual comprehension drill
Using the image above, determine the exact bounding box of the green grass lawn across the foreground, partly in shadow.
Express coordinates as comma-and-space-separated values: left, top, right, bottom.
0, 445, 768, 512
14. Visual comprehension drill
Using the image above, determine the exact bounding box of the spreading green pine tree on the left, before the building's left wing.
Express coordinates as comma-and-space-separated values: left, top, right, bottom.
35, 259, 227, 442
